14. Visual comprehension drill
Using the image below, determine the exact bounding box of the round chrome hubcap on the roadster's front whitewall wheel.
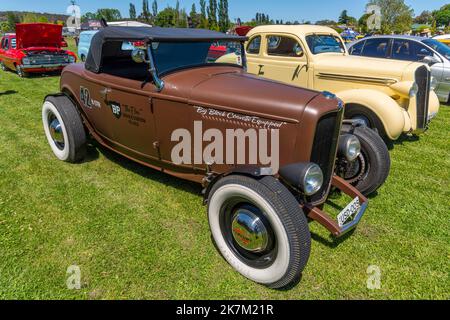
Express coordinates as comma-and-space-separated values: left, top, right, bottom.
231, 209, 269, 253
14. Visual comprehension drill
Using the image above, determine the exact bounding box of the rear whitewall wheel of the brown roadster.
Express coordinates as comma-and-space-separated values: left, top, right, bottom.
42, 96, 86, 163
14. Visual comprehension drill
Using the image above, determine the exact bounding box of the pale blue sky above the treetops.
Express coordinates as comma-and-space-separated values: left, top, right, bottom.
0, 0, 448, 21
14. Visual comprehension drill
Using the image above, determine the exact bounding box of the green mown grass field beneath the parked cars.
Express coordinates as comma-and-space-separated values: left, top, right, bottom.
0, 38, 450, 299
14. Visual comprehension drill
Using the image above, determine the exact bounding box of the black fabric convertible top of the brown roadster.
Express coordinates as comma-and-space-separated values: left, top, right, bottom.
85, 26, 247, 73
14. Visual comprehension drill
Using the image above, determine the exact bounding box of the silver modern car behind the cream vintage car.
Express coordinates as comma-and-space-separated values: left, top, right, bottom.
348, 35, 450, 103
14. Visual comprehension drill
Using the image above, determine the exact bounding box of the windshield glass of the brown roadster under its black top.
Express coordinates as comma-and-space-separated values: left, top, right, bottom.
152, 41, 242, 75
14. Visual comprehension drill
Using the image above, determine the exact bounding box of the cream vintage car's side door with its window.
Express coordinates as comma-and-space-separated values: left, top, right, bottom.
259, 33, 308, 87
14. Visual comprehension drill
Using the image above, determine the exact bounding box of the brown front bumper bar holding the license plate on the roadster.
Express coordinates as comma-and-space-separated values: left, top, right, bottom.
303, 175, 369, 237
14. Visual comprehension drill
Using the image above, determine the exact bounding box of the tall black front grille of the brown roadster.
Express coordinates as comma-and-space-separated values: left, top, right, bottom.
307, 109, 344, 203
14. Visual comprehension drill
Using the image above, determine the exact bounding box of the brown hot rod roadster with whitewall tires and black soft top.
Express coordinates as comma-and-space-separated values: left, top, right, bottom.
42, 27, 389, 288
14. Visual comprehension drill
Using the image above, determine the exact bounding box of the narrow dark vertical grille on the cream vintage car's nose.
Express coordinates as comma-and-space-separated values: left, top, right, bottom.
415, 66, 431, 129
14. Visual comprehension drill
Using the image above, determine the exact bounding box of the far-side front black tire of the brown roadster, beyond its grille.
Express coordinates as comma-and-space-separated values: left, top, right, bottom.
341, 125, 391, 196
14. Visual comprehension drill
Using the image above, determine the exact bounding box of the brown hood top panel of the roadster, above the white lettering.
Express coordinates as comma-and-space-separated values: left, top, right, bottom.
164, 67, 319, 120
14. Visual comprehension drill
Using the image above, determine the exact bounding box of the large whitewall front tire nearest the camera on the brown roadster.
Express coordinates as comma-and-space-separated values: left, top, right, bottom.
208, 175, 311, 289
